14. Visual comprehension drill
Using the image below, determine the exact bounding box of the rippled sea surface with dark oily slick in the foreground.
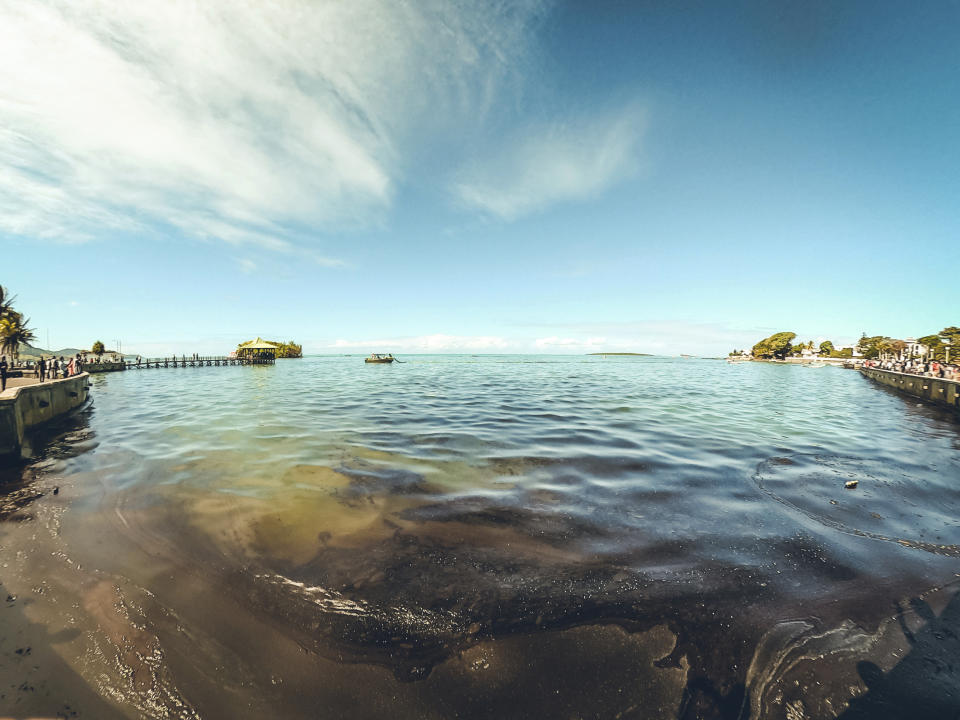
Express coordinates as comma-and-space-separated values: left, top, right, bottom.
0, 356, 960, 720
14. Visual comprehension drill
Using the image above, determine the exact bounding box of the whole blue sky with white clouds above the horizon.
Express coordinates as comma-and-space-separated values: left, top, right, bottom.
0, 0, 960, 355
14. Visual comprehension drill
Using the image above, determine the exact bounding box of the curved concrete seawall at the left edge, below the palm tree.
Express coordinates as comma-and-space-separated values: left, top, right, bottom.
0, 373, 90, 457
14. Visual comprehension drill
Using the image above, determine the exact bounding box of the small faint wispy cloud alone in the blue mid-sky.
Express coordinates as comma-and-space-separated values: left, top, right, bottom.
455, 105, 645, 220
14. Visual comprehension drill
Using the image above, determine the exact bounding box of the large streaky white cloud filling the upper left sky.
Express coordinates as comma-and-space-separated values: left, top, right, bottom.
0, 0, 539, 249
